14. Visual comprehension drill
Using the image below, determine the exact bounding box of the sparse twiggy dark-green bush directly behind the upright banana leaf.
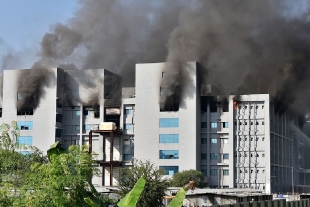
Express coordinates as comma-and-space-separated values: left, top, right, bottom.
118, 160, 169, 207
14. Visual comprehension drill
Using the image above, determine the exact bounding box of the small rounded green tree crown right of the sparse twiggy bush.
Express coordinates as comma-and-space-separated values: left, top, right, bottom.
170, 170, 207, 188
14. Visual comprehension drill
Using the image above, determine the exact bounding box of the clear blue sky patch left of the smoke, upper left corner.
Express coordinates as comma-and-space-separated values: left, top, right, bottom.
0, 0, 79, 68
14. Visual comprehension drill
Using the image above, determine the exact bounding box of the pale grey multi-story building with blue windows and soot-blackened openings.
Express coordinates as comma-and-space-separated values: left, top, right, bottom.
1, 62, 310, 193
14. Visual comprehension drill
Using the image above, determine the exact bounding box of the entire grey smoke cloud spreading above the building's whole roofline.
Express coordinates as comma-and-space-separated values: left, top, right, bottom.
1, 0, 310, 111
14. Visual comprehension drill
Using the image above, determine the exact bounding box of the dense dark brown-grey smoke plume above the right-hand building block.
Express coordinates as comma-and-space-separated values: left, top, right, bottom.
163, 0, 310, 113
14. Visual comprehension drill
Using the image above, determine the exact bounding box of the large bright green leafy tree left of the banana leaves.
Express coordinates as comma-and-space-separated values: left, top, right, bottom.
14, 144, 93, 207
